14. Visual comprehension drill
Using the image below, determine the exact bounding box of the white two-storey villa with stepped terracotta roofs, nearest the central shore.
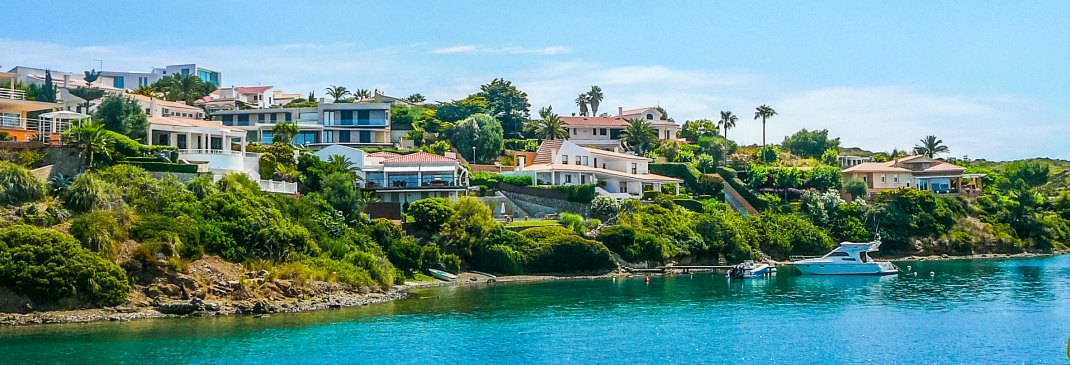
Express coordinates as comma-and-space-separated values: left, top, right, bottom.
506, 140, 683, 198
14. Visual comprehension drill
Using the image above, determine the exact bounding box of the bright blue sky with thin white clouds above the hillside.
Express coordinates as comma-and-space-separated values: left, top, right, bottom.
0, 0, 1070, 159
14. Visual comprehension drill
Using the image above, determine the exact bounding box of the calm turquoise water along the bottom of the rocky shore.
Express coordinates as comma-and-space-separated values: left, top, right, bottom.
0, 256, 1070, 364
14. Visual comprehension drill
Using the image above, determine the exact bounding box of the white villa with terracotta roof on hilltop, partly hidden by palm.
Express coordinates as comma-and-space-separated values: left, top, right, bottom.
561, 107, 681, 152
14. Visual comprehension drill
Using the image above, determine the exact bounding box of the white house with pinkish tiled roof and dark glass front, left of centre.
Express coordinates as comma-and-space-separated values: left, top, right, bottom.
314, 145, 469, 206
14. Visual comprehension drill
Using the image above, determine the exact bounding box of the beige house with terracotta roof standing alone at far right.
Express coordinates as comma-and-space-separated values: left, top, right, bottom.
843, 155, 984, 196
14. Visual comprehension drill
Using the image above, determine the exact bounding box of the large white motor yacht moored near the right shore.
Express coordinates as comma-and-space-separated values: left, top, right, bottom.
791, 235, 899, 275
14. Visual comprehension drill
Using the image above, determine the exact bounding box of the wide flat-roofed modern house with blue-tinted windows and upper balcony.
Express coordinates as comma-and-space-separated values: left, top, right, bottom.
211, 103, 392, 147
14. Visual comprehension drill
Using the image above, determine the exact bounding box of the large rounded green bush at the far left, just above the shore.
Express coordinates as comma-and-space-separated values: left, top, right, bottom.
0, 226, 129, 305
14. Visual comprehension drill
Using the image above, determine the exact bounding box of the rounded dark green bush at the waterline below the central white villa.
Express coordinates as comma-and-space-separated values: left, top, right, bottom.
529, 235, 616, 273
